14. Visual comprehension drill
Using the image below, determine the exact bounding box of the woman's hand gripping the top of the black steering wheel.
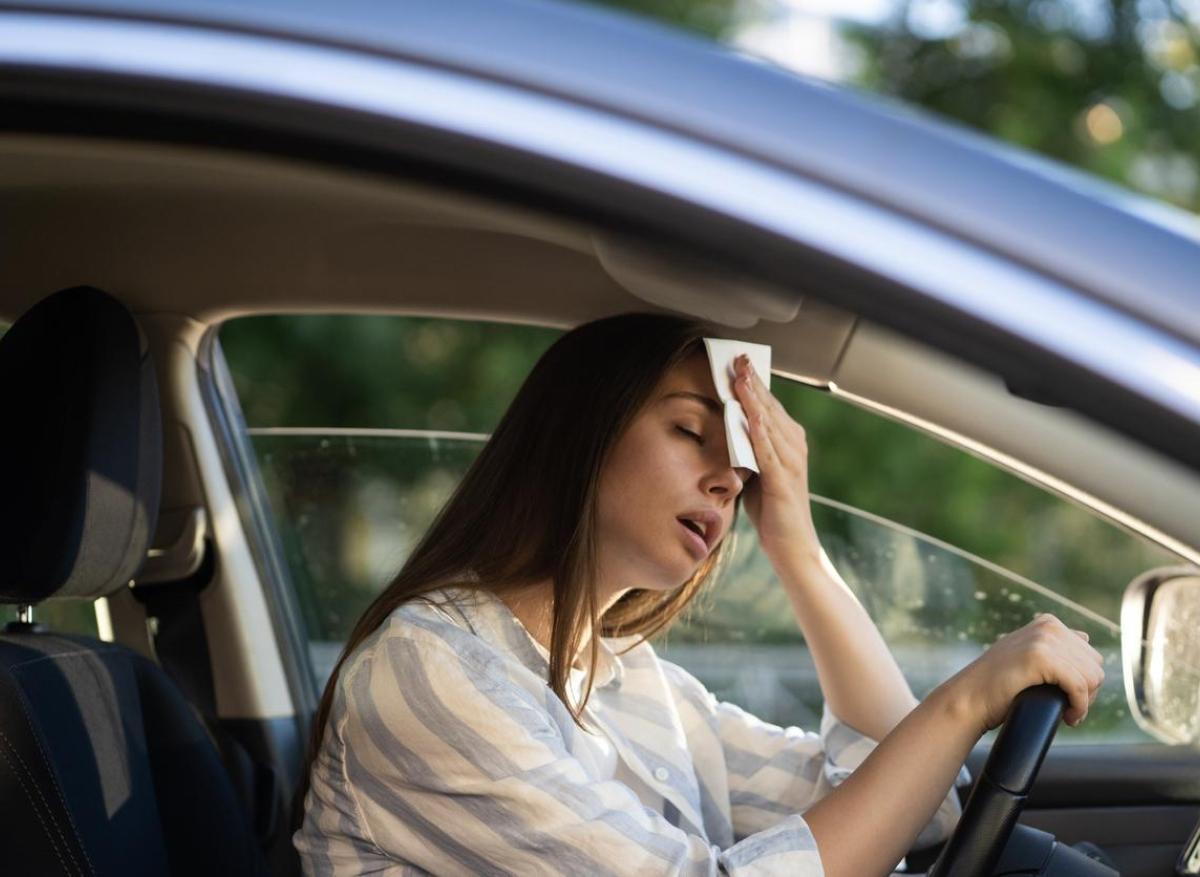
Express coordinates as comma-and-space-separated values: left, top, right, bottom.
946, 613, 1104, 735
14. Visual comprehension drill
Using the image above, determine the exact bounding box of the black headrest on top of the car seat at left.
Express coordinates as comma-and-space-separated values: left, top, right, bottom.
0, 287, 162, 603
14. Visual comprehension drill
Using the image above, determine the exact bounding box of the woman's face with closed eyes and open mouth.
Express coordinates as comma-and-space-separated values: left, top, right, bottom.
598, 353, 752, 593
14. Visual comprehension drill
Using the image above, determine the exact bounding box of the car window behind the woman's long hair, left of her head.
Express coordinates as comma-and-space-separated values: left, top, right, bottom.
220, 316, 558, 671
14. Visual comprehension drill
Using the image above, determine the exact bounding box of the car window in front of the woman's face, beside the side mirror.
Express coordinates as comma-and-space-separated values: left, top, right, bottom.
660, 378, 1182, 743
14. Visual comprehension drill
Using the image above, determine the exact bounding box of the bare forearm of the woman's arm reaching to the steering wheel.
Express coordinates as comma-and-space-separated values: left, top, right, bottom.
804, 684, 983, 877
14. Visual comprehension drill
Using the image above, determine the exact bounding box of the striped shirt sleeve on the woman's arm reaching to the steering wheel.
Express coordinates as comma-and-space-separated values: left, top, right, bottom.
321, 630, 823, 877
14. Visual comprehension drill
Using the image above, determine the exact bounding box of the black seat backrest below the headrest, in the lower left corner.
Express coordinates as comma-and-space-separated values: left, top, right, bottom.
0, 633, 263, 876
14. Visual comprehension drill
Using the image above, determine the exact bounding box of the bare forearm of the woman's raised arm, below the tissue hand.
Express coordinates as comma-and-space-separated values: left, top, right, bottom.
778, 551, 917, 740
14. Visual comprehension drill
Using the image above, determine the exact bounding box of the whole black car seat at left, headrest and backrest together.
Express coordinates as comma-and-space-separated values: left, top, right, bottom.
0, 288, 266, 877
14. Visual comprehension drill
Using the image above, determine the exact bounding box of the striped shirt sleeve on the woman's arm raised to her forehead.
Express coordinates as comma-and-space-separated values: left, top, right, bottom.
664, 661, 971, 849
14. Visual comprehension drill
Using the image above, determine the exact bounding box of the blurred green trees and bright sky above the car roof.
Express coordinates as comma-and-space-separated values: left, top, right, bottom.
604, 0, 1200, 211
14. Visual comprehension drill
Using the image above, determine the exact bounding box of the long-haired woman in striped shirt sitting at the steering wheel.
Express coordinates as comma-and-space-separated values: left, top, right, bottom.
295, 314, 1104, 877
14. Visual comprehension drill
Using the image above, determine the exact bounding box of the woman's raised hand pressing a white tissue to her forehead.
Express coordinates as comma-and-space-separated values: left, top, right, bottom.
733, 355, 822, 575
